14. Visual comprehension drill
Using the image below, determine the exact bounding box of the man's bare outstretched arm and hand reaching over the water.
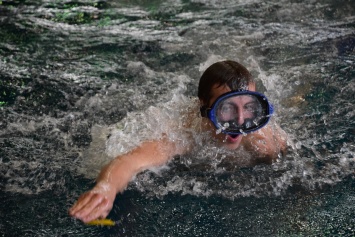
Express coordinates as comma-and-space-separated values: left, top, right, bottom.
69, 139, 178, 222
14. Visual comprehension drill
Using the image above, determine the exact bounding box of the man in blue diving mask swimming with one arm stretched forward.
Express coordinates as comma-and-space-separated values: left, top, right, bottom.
69, 60, 286, 223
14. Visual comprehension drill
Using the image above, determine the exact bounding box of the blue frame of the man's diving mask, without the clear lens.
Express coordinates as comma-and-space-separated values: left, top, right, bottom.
200, 90, 274, 135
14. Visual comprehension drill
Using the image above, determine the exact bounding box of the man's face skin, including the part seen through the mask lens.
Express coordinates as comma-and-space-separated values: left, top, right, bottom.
203, 84, 255, 150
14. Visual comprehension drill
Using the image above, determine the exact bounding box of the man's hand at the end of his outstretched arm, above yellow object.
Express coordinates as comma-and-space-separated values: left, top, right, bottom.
69, 182, 116, 222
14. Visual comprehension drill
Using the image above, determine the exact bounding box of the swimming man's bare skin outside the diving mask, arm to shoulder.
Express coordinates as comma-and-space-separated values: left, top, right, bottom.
69, 81, 286, 222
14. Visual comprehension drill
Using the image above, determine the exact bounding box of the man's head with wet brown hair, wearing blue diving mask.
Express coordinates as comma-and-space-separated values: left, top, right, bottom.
198, 60, 273, 149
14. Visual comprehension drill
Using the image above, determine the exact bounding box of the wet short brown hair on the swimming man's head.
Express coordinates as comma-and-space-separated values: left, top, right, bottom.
198, 60, 255, 103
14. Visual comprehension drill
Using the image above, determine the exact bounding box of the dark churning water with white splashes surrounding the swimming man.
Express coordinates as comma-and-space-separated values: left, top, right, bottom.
0, 0, 355, 237
